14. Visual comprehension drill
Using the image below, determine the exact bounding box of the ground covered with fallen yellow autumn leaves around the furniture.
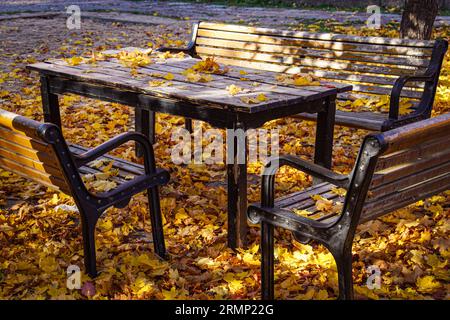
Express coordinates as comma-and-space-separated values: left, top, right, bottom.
0, 18, 450, 299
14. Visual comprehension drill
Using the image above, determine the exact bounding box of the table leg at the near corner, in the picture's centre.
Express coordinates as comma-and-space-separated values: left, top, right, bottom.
227, 124, 248, 249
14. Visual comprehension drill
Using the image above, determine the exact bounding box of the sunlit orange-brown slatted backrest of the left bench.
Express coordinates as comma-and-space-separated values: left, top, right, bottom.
0, 109, 74, 194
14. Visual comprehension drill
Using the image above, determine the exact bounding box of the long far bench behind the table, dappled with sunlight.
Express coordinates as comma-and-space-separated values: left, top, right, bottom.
160, 22, 448, 131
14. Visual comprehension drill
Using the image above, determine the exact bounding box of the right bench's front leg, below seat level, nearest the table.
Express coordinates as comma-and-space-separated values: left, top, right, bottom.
261, 221, 274, 300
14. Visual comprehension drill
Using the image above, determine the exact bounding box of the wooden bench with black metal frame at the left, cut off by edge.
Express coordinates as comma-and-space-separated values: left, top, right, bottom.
0, 109, 169, 277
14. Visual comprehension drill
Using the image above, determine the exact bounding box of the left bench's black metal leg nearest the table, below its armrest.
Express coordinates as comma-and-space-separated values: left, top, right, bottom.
147, 187, 167, 259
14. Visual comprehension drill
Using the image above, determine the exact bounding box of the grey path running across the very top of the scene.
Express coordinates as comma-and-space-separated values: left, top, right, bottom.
0, 0, 450, 26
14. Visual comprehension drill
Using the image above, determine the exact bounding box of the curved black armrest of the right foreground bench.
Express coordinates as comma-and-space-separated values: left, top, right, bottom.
261, 155, 350, 207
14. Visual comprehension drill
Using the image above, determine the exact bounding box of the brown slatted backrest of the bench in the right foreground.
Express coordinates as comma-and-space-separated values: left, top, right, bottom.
344, 113, 450, 223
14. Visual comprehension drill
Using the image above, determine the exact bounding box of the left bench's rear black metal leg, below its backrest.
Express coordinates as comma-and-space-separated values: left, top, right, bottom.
81, 211, 97, 278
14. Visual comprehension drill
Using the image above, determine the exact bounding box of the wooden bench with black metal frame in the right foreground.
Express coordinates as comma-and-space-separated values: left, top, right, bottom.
248, 113, 450, 299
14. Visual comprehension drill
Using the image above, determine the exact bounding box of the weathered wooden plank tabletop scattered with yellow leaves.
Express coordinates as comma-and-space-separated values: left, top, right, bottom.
30, 58, 348, 113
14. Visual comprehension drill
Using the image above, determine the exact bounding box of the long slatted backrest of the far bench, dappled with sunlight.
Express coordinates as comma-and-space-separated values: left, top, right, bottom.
192, 22, 447, 102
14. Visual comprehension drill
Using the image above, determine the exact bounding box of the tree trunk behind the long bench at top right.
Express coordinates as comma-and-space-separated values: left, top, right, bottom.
400, 0, 439, 40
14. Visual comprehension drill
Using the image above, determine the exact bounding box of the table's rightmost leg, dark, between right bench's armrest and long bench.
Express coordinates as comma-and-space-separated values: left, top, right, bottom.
314, 96, 336, 169
